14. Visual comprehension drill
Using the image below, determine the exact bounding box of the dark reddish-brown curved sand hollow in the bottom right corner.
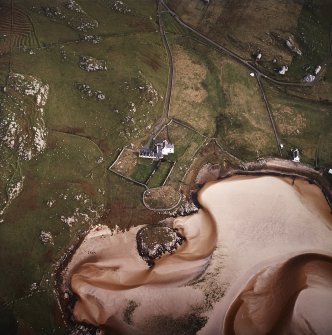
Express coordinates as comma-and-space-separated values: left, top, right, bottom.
224, 254, 332, 335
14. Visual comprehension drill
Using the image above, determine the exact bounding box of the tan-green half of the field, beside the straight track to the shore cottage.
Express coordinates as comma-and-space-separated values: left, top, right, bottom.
217, 60, 276, 160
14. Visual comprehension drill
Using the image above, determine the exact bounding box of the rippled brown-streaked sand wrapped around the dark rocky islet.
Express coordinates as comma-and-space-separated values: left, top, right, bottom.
68, 211, 217, 334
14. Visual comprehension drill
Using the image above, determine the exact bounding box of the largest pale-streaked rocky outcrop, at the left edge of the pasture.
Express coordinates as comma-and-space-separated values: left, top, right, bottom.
0, 73, 49, 160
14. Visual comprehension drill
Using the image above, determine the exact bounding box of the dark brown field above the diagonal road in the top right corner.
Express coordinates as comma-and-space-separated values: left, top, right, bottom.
168, 0, 332, 80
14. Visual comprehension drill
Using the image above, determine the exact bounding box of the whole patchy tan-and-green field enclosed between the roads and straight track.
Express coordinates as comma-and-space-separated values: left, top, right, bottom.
166, 12, 276, 160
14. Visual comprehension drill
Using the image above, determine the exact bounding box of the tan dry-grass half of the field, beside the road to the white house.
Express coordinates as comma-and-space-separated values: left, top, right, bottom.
170, 37, 221, 136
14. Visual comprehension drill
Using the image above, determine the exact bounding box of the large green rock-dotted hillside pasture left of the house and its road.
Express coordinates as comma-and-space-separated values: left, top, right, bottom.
0, 1, 167, 335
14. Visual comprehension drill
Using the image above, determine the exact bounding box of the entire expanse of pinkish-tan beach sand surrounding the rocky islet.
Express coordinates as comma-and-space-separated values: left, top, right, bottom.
67, 177, 332, 335
